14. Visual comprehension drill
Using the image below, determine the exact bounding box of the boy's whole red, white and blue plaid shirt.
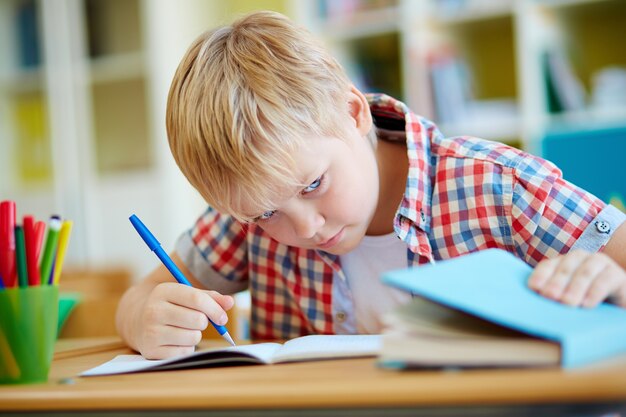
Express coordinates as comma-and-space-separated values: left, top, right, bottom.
177, 95, 625, 339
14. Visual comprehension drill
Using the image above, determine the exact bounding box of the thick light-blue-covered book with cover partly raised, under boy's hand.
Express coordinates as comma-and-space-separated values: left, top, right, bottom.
379, 249, 626, 368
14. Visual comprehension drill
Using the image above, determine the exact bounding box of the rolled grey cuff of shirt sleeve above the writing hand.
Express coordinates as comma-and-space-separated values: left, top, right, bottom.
174, 231, 248, 294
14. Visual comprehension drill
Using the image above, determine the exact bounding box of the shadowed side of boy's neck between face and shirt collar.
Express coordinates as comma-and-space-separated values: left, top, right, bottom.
366, 140, 409, 236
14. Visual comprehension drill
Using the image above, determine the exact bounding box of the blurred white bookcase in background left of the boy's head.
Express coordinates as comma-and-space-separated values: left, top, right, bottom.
0, 0, 225, 274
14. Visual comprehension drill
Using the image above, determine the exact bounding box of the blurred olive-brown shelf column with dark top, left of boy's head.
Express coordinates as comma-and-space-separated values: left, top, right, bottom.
85, 0, 152, 175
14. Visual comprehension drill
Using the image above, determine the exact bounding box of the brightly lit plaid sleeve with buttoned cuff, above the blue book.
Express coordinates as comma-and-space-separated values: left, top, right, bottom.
511, 155, 626, 266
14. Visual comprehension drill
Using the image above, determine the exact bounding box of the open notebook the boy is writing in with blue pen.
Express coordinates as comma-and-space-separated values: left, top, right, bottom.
80, 335, 380, 376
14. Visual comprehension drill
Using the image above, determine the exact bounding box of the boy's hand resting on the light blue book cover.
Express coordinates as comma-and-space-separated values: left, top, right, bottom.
528, 250, 626, 307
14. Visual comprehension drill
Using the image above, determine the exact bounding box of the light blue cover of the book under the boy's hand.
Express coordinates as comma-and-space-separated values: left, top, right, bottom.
382, 249, 626, 368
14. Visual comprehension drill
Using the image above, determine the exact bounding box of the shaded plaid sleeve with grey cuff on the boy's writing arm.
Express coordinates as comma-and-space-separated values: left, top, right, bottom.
175, 207, 248, 294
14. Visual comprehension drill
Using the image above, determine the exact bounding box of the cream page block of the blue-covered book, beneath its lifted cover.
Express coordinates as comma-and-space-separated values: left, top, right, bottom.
379, 298, 560, 368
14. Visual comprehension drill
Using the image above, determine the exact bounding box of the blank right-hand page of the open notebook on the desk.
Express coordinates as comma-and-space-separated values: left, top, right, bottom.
272, 335, 381, 363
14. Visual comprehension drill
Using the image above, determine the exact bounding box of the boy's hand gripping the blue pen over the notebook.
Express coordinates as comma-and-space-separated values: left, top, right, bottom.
134, 282, 234, 359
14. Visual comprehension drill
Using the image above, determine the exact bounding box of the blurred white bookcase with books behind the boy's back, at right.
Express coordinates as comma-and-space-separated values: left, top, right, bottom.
293, 0, 626, 150
